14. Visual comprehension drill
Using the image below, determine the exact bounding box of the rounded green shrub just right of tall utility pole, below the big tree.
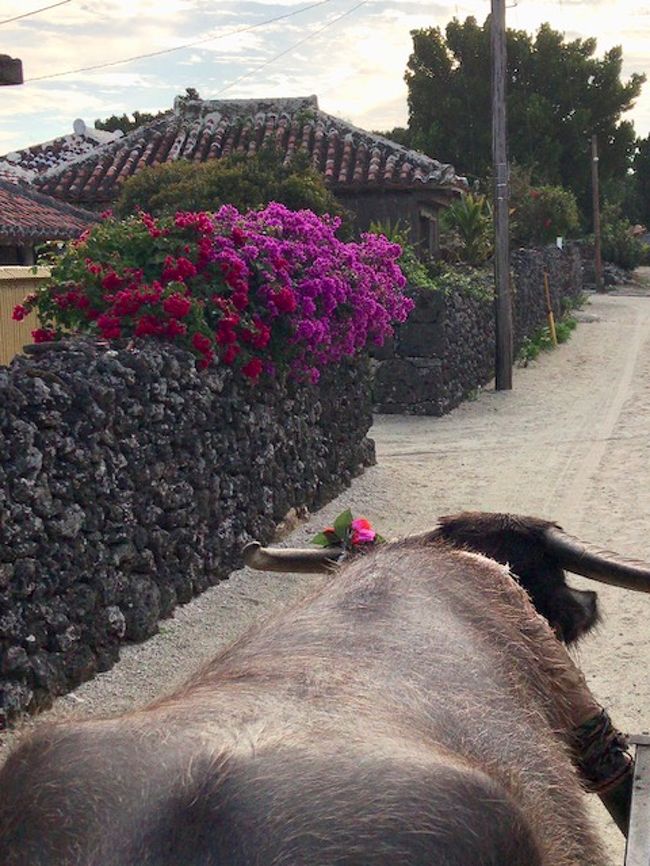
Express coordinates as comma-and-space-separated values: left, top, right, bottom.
511, 186, 580, 244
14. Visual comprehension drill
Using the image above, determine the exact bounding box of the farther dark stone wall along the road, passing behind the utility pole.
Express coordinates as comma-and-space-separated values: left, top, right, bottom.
373, 246, 583, 415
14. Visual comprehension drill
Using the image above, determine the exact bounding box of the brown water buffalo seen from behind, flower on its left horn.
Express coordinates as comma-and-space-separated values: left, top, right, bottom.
0, 515, 650, 866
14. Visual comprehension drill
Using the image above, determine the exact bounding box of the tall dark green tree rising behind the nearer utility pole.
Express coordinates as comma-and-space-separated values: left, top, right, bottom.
405, 17, 645, 209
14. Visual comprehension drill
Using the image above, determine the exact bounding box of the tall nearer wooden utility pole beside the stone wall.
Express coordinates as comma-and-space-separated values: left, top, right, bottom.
491, 0, 512, 391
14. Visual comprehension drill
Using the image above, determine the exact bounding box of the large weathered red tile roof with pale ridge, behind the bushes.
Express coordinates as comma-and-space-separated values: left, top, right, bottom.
17, 96, 466, 206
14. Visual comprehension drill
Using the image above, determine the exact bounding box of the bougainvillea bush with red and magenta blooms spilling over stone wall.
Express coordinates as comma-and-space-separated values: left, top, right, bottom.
14, 203, 412, 381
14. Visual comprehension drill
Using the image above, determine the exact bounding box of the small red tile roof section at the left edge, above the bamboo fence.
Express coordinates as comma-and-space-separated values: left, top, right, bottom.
0, 181, 98, 246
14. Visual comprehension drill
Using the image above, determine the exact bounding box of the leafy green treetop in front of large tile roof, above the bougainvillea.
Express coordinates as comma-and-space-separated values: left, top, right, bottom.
116, 148, 346, 223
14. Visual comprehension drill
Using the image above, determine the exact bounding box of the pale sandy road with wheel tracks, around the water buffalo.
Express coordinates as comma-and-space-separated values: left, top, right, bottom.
3, 289, 650, 866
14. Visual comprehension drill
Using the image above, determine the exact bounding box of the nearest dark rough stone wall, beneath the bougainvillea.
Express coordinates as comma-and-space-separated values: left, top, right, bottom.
0, 340, 374, 727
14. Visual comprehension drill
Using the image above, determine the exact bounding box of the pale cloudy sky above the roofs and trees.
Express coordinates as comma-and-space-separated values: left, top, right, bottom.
0, 0, 650, 161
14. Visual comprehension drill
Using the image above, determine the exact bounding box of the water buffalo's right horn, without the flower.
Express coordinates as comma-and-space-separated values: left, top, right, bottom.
544, 526, 650, 592
